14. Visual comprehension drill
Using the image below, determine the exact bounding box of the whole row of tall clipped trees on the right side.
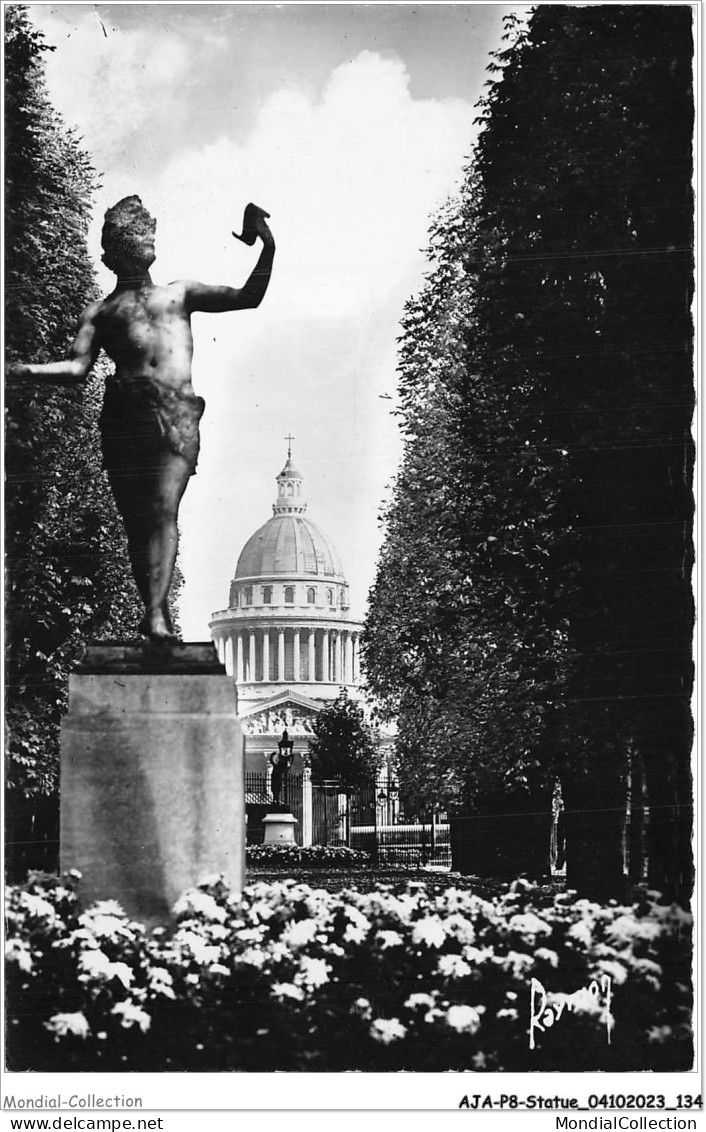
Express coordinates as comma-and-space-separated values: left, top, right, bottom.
364, 6, 694, 898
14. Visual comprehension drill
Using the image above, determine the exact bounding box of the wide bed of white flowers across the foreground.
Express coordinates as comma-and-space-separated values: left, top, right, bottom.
7, 878, 691, 1072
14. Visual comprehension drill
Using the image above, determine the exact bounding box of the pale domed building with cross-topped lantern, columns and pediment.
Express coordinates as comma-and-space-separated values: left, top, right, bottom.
209, 446, 362, 773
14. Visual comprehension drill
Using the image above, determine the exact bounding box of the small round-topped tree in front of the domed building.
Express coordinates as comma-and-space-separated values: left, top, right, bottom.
309, 688, 381, 790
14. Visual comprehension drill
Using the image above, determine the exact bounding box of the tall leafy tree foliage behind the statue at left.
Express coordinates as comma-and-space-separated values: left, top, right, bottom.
5, 5, 183, 860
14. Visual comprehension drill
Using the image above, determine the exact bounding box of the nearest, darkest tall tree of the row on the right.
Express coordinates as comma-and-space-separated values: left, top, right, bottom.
476, 6, 694, 897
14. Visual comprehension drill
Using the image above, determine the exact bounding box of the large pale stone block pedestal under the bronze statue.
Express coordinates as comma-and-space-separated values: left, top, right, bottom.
60, 642, 246, 923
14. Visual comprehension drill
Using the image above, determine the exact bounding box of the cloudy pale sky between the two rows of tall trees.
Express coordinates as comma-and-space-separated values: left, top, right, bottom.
29, 3, 510, 640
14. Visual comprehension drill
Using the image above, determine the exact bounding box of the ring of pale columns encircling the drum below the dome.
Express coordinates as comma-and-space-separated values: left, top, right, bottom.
215, 627, 360, 684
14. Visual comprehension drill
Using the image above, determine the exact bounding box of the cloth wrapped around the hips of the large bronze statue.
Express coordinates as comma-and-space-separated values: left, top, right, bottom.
100, 376, 206, 475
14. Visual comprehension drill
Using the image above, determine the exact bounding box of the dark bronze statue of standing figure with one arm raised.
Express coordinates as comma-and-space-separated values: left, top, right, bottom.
10, 196, 275, 641
